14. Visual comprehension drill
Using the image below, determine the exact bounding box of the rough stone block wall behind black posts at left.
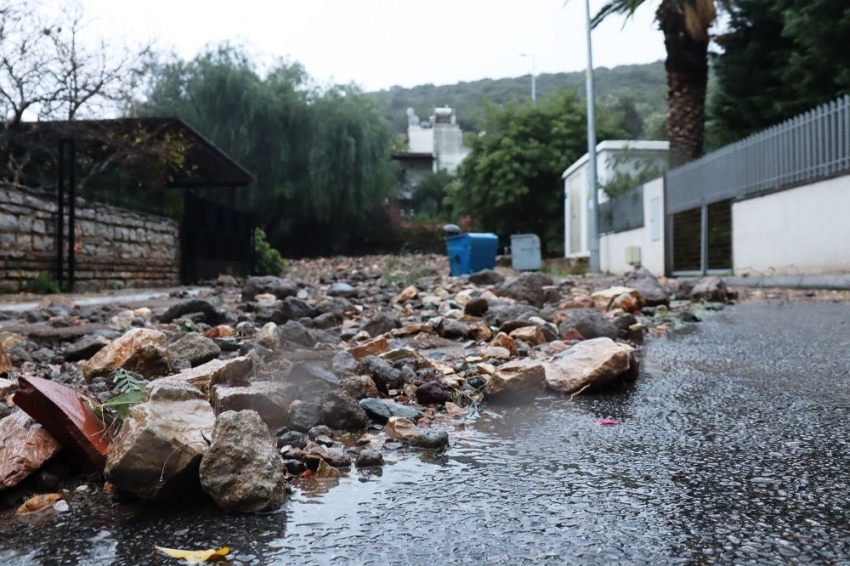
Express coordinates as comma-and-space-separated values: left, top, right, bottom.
0, 187, 180, 292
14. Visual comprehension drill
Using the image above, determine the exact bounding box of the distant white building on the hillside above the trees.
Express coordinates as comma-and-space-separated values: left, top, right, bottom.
407, 108, 471, 175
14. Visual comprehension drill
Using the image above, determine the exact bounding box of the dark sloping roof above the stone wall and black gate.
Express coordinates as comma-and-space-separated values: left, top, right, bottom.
19, 117, 254, 189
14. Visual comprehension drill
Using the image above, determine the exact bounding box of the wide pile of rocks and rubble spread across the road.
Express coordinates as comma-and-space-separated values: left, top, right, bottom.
0, 259, 729, 512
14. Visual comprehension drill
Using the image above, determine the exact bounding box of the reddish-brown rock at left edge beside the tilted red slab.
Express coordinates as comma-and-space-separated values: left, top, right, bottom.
0, 411, 62, 491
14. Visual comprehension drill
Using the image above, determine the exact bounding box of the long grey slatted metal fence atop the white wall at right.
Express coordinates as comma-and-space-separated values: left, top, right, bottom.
666, 96, 850, 214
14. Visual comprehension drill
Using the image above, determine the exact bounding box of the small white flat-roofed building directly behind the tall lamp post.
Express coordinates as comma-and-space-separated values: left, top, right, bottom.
561, 140, 670, 258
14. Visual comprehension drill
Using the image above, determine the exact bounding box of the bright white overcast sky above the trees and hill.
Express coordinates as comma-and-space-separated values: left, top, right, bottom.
82, 0, 664, 91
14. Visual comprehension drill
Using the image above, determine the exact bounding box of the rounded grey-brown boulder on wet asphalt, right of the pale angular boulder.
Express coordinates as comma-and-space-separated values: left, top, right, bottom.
200, 411, 286, 513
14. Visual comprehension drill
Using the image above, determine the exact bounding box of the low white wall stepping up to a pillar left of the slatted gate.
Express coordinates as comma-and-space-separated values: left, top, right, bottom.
599, 178, 664, 277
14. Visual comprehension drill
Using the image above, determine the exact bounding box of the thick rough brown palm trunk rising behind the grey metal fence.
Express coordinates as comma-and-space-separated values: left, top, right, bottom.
656, 0, 708, 168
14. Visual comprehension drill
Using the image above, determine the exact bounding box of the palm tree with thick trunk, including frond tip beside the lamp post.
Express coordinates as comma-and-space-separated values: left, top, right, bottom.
593, 0, 723, 167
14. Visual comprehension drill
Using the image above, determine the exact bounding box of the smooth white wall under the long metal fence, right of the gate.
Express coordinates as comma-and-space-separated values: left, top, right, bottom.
732, 175, 850, 275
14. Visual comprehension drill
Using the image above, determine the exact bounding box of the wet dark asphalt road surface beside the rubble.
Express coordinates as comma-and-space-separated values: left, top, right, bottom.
0, 303, 850, 566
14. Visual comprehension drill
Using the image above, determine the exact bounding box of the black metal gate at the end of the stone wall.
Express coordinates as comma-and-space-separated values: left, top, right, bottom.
180, 190, 254, 285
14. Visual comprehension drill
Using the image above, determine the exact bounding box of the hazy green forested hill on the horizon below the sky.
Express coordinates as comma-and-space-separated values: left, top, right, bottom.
367, 61, 667, 132
